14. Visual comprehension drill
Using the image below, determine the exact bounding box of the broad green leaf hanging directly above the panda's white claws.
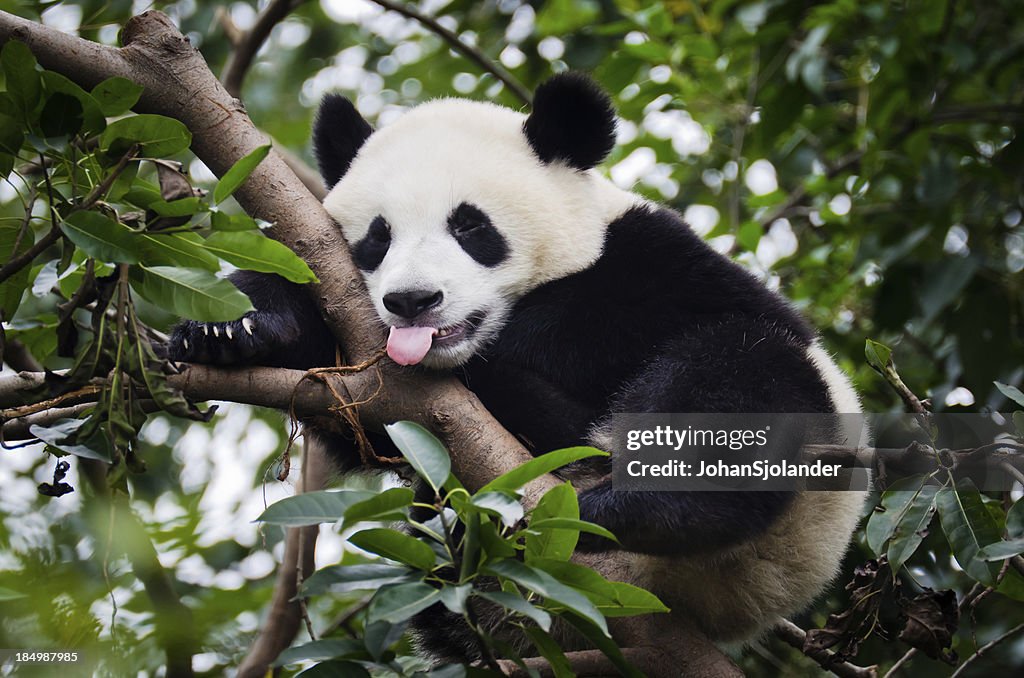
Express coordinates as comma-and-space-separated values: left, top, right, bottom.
131, 266, 253, 323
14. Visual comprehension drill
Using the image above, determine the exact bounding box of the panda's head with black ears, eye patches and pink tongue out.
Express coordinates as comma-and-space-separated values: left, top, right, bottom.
313, 73, 628, 369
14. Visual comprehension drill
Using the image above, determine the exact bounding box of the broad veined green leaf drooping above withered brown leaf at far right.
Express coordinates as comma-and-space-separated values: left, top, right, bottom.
935, 482, 1000, 586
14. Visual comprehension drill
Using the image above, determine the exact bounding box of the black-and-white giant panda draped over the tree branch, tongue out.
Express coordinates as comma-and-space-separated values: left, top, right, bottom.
170, 73, 864, 658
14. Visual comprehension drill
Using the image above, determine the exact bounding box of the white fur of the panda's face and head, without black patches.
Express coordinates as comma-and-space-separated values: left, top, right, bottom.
324, 99, 639, 369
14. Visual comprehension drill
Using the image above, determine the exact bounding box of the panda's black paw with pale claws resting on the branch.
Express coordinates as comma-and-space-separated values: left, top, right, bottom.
167, 311, 294, 365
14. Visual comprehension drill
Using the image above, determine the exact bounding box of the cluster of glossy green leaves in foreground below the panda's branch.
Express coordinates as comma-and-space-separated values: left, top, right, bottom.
260, 422, 668, 675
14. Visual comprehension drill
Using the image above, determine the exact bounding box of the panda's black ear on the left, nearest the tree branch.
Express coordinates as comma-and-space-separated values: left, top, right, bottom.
313, 94, 374, 189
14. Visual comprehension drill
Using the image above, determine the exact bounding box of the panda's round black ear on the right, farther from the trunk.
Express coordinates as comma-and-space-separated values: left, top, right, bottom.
523, 71, 615, 170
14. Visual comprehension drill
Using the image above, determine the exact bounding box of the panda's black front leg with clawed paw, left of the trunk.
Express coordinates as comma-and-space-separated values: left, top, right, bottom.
167, 271, 335, 369
